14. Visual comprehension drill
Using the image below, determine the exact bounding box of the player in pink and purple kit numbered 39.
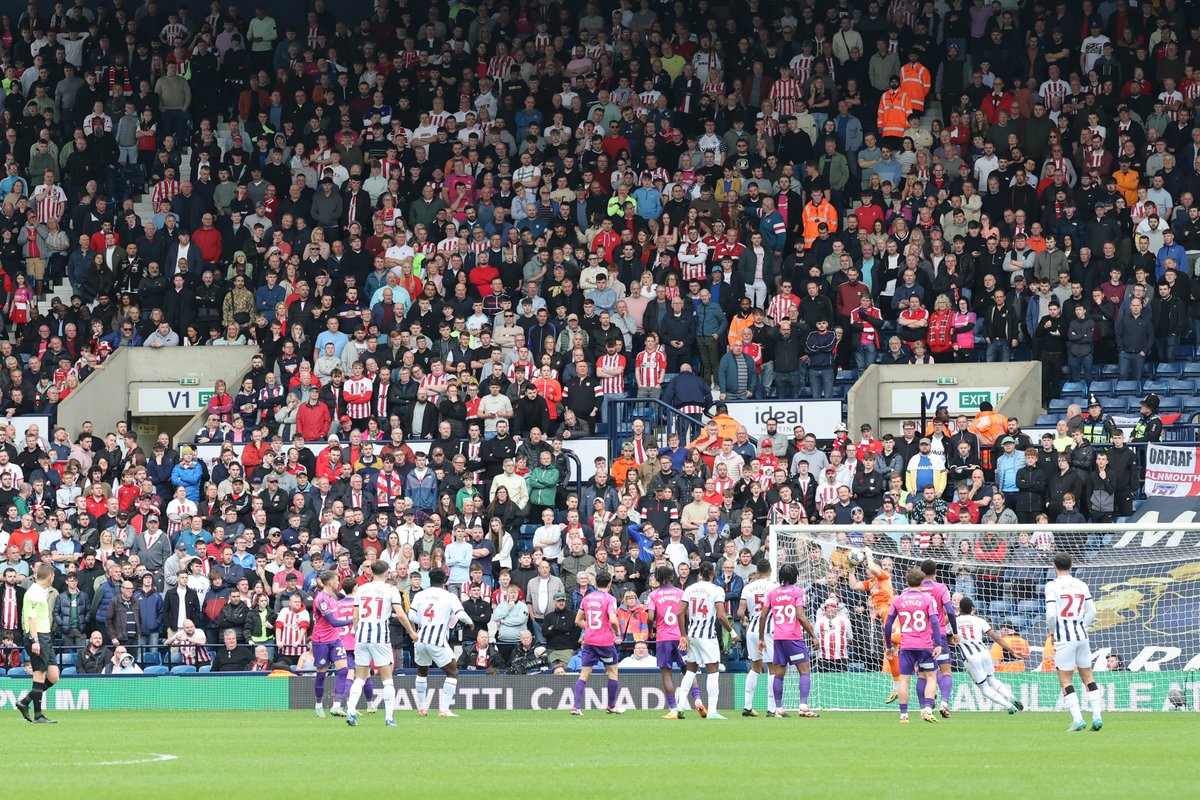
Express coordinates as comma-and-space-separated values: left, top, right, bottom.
758, 564, 820, 717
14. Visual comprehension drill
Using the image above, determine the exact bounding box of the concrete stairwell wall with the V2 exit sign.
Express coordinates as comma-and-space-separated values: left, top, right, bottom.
846, 361, 1042, 435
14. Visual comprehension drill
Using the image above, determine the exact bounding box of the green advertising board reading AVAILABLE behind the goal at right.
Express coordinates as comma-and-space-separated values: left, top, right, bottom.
739, 672, 1200, 711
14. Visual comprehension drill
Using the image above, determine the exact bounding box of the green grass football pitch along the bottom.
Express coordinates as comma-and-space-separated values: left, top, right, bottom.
0, 711, 1200, 800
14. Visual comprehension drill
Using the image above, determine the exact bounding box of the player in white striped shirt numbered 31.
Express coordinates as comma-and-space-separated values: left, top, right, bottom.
346, 561, 416, 728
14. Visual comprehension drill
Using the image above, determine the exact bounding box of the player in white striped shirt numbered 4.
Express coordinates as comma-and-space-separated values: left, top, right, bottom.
408, 569, 472, 717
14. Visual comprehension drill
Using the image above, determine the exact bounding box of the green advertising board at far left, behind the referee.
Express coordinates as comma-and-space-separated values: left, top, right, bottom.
0, 674, 290, 711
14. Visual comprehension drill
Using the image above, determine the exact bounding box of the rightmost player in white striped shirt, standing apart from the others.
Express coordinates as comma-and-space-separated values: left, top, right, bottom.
1046, 553, 1104, 733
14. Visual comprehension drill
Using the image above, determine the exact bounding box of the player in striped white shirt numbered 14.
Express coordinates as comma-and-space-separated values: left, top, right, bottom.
677, 561, 738, 720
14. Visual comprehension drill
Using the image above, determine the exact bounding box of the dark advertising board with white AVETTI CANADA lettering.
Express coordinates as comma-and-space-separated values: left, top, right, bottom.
289, 669, 739, 712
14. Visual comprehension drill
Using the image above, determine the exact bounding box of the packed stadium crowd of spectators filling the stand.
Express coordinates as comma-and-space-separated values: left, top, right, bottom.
0, 0, 1200, 670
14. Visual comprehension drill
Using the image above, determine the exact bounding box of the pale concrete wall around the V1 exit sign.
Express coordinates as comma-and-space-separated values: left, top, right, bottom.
59, 347, 258, 435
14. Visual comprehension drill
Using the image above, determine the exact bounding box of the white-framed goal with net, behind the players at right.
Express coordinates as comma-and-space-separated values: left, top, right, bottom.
756, 523, 1200, 711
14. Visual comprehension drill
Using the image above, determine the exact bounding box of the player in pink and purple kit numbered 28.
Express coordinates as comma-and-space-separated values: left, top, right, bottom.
883, 567, 942, 724
